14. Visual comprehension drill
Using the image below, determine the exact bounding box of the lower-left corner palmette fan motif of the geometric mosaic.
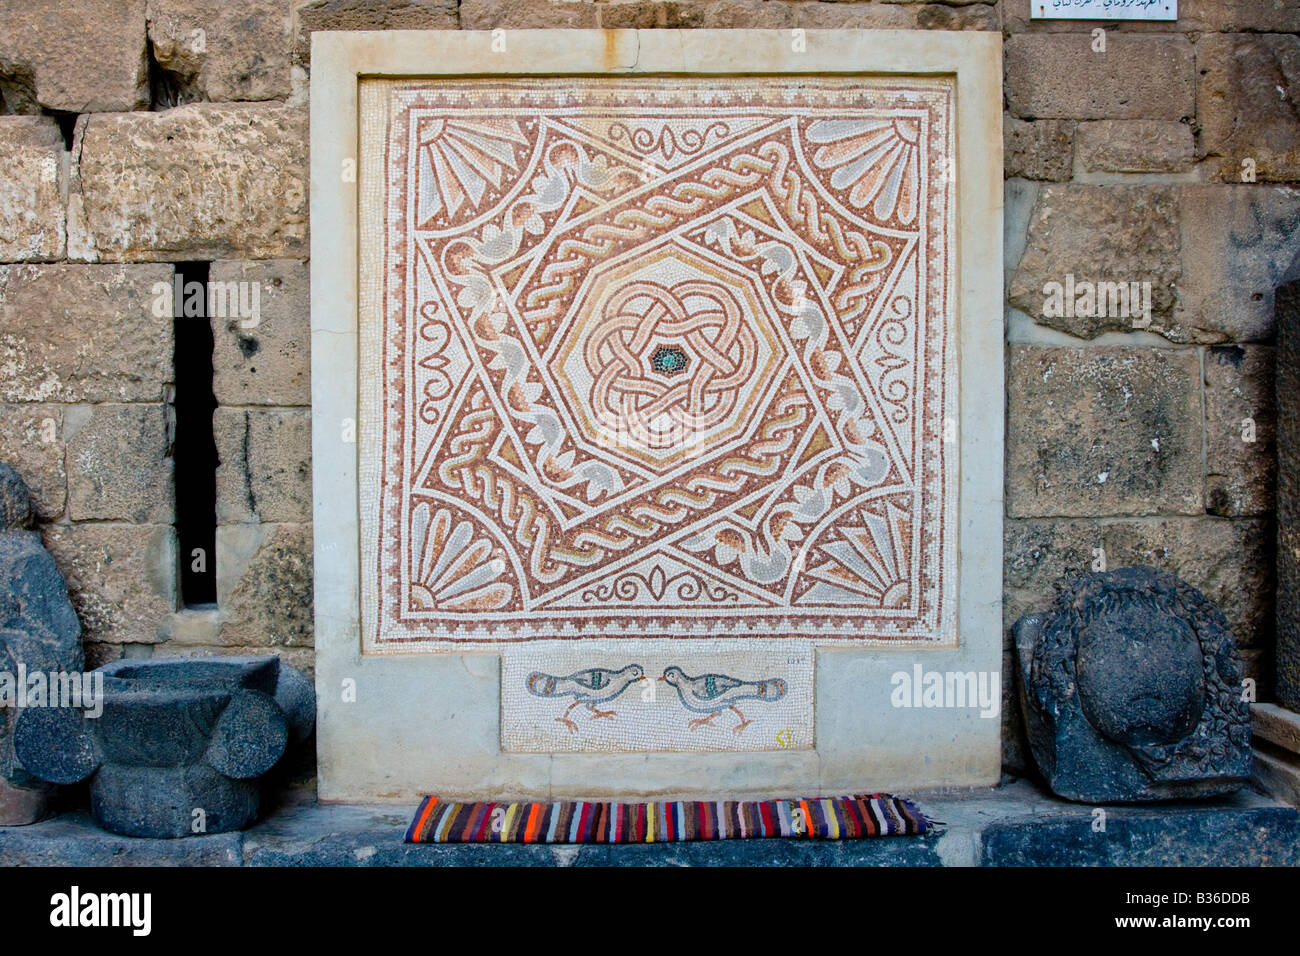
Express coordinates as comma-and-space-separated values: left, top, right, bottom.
411, 502, 515, 611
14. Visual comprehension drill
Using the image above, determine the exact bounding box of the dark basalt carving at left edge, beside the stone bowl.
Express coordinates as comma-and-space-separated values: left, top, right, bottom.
0, 464, 82, 826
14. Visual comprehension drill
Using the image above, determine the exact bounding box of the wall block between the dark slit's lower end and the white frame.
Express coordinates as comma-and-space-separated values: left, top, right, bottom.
217, 524, 312, 648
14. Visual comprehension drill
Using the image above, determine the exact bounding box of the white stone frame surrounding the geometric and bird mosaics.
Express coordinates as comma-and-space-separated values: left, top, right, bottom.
311, 30, 1005, 803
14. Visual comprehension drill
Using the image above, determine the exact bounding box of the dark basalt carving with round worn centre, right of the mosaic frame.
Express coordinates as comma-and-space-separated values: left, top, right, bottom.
1015, 567, 1251, 803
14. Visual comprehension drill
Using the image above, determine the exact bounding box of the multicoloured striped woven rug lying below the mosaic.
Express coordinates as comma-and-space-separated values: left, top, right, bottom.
406, 793, 932, 843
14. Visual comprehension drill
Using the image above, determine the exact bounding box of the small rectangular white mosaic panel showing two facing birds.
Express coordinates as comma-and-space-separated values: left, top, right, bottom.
501, 639, 814, 753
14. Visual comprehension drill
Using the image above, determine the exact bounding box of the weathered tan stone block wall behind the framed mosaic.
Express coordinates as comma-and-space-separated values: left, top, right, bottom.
0, 0, 1300, 767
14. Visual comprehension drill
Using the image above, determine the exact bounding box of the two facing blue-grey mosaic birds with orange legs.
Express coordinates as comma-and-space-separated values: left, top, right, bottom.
528, 663, 787, 736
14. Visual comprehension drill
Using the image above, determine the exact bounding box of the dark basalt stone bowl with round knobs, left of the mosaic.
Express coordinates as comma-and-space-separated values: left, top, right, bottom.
14, 657, 316, 838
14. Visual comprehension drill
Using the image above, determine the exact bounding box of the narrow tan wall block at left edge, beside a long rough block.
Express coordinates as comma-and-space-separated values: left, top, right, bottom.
0, 116, 66, 261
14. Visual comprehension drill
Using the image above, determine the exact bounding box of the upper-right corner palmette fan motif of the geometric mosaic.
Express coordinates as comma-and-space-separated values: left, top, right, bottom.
807, 117, 920, 225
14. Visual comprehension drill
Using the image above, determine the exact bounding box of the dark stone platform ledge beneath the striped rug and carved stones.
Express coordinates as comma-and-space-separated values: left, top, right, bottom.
0, 780, 1300, 866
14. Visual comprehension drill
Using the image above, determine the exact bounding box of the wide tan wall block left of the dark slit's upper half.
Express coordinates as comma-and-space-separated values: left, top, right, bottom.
0, 265, 173, 402
